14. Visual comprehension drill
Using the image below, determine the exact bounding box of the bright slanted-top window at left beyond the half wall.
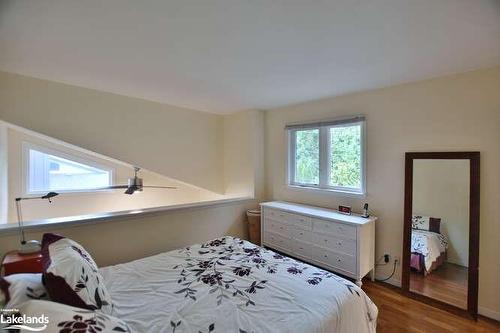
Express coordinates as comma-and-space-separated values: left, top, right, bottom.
25, 146, 112, 194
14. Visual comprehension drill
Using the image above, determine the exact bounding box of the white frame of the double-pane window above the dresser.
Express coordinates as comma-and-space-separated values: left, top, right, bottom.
286, 120, 366, 197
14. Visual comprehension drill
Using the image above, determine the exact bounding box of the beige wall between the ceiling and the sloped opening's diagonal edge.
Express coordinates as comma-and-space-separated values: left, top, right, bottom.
0, 72, 224, 193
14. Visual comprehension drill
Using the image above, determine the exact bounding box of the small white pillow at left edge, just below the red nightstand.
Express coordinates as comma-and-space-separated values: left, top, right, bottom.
0, 273, 49, 309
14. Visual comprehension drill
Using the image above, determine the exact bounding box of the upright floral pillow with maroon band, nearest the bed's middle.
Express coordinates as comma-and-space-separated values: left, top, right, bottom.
42, 234, 113, 314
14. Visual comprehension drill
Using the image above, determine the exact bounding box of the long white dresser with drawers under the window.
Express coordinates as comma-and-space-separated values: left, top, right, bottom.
261, 201, 377, 286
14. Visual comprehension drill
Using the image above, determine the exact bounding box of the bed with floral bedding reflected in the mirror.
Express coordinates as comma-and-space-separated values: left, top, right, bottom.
410, 229, 448, 275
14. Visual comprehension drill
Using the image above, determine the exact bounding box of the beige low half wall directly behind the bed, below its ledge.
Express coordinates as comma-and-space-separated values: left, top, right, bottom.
0, 201, 256, 266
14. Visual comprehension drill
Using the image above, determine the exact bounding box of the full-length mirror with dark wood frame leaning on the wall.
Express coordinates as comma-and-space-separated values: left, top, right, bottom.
403, 152, 479, 317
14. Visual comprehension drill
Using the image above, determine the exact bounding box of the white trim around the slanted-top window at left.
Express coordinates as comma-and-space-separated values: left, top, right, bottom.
21, 142, 115, 197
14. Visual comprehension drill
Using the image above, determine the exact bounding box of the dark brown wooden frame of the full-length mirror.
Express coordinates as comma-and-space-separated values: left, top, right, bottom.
401, 152, 480, 320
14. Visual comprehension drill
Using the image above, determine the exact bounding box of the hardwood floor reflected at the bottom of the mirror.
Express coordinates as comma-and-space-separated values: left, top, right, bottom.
410, 262, 467, 309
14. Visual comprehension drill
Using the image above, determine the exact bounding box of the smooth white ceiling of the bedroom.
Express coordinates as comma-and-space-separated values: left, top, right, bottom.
0, 0, 500, 113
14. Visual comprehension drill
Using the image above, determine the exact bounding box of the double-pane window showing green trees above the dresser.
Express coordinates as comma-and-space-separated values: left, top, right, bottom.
286, 117, 365, 194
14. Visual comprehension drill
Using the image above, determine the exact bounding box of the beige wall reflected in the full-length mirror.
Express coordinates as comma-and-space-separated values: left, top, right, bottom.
412, 159, 470, 267
